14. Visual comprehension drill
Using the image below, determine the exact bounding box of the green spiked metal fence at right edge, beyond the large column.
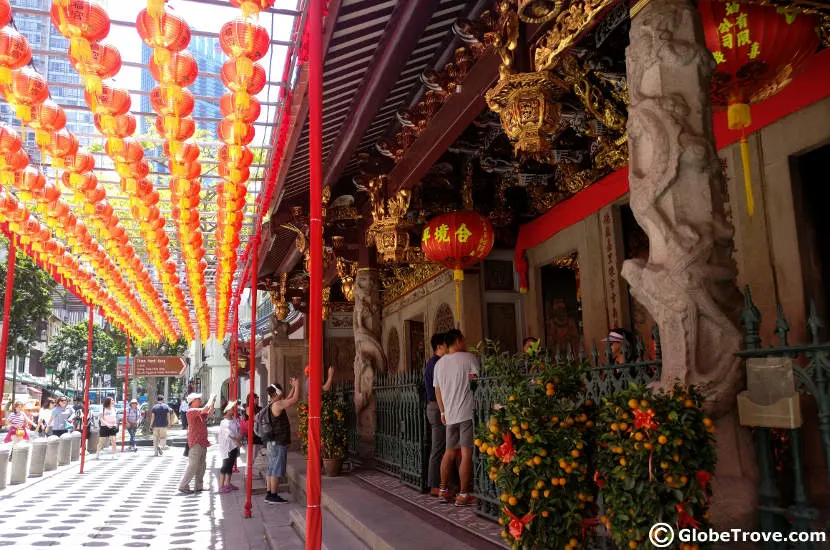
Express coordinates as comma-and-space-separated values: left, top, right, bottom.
738, 287, 830, 549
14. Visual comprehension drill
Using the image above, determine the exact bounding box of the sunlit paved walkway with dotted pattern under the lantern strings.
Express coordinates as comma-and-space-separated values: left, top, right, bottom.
0, 438, 280, 550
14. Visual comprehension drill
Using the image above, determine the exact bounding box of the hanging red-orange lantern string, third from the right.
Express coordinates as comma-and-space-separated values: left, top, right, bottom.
52, 0, 193, 340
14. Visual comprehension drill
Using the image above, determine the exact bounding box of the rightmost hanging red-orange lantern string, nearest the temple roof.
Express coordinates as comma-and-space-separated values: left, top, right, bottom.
215, 0, 274, 340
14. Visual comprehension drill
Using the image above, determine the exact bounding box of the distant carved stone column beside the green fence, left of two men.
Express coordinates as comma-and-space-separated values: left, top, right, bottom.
353, 268, 386, 458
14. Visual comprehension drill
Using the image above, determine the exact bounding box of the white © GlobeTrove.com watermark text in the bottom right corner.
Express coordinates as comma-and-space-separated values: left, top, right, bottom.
648, 523, 827, 548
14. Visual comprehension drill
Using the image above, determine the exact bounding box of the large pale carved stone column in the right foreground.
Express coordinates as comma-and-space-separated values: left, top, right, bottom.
622, 0, 758, 528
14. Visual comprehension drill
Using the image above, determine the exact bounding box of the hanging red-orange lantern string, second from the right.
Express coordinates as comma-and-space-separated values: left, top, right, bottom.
136, 0, 210, 340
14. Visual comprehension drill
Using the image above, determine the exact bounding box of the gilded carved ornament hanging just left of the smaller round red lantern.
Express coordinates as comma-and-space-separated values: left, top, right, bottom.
366, 174, 411, 263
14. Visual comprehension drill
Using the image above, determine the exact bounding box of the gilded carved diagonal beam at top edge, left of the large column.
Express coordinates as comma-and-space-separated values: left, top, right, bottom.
532, 0, 616, 71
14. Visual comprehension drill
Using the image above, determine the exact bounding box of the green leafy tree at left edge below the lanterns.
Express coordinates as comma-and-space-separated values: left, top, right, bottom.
0, 239, 55, 357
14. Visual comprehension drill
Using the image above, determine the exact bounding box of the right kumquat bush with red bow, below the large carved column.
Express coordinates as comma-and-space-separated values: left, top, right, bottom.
595, 385, 716, 550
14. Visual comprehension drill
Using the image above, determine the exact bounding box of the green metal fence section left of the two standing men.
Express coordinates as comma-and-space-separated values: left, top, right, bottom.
375, 369, 429, 491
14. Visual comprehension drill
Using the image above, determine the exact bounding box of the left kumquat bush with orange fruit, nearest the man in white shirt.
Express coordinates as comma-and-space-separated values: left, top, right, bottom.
475, 344, 597, 550
